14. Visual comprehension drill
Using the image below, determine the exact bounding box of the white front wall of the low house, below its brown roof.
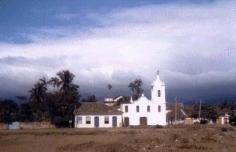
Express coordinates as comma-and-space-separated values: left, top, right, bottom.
75, 115, 122, 128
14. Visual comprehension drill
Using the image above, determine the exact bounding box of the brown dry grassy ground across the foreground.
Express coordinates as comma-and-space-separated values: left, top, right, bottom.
0, 126, 236, 152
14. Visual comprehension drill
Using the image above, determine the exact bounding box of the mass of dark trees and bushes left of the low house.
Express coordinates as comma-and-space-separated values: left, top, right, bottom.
0, 70, 80, 127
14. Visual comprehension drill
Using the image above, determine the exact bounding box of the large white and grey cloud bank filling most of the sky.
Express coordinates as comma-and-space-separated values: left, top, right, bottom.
0, 2, 236, 100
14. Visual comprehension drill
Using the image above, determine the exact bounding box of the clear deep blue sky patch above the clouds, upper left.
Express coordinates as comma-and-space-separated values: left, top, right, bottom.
0, 0, 213, 43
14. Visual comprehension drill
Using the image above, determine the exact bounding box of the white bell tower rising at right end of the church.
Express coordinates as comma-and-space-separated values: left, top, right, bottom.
151, 70, 166, 104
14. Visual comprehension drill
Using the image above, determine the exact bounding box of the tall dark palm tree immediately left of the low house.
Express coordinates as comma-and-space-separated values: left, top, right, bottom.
49, 70, 80, 127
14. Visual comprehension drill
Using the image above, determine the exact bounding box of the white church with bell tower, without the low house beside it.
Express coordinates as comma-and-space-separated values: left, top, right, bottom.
121, 72, 167, 126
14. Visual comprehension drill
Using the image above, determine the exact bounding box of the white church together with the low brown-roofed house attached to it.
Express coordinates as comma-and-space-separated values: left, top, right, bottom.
74, 72, 167, 128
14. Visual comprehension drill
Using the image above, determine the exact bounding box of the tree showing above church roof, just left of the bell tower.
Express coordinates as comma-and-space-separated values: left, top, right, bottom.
128, 79, 143, 100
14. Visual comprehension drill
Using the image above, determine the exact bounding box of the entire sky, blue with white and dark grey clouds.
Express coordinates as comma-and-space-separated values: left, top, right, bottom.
0, 0, 236, 102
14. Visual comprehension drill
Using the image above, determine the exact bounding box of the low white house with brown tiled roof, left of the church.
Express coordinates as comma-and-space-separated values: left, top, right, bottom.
74, 102, 122, 128
